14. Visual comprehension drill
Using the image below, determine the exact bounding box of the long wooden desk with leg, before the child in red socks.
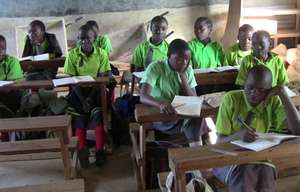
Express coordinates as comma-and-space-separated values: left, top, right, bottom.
0, 77, 109, 131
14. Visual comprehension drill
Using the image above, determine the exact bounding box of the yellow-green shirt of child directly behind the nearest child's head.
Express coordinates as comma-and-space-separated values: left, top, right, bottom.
235, 52, 289, 87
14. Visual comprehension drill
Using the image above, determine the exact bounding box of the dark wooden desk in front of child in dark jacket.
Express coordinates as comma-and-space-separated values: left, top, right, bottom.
20, 57, 65, 72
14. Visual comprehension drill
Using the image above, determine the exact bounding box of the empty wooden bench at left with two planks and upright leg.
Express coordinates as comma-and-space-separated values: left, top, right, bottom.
0, 115, 77, 179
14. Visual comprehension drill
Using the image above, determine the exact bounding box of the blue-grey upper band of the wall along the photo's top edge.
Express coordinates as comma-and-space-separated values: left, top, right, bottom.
0, 0, 229, 17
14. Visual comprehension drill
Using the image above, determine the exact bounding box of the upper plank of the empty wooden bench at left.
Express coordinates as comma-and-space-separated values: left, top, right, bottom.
0, 115, 71, 132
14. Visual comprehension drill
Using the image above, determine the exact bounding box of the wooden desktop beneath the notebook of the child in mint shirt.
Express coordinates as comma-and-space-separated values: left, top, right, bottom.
135, 104, 218, 123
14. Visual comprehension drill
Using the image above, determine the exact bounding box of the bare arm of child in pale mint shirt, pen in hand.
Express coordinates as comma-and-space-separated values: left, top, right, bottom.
140, 83, 175, 114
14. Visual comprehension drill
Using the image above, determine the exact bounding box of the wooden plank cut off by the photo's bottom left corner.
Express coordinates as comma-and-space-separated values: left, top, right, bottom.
0, 179, 85, 192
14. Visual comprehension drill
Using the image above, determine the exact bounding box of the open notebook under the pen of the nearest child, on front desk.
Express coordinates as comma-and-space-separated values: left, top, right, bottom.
230, 133, 298, 151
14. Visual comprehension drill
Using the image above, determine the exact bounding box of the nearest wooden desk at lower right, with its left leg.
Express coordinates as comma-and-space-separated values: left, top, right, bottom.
169, 138, 300, 192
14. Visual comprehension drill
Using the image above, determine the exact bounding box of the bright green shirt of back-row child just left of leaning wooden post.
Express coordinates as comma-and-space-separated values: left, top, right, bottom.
188, 39, 224, 69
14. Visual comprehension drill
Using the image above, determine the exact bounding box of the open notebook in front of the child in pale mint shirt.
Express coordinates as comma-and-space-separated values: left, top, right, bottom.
171, 95, 203, 117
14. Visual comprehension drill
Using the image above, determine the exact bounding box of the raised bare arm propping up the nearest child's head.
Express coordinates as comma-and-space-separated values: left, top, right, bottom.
266, 85, 300, 135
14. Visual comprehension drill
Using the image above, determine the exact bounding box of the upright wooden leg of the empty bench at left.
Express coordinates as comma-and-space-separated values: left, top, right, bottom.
59, 131, 71, 179
